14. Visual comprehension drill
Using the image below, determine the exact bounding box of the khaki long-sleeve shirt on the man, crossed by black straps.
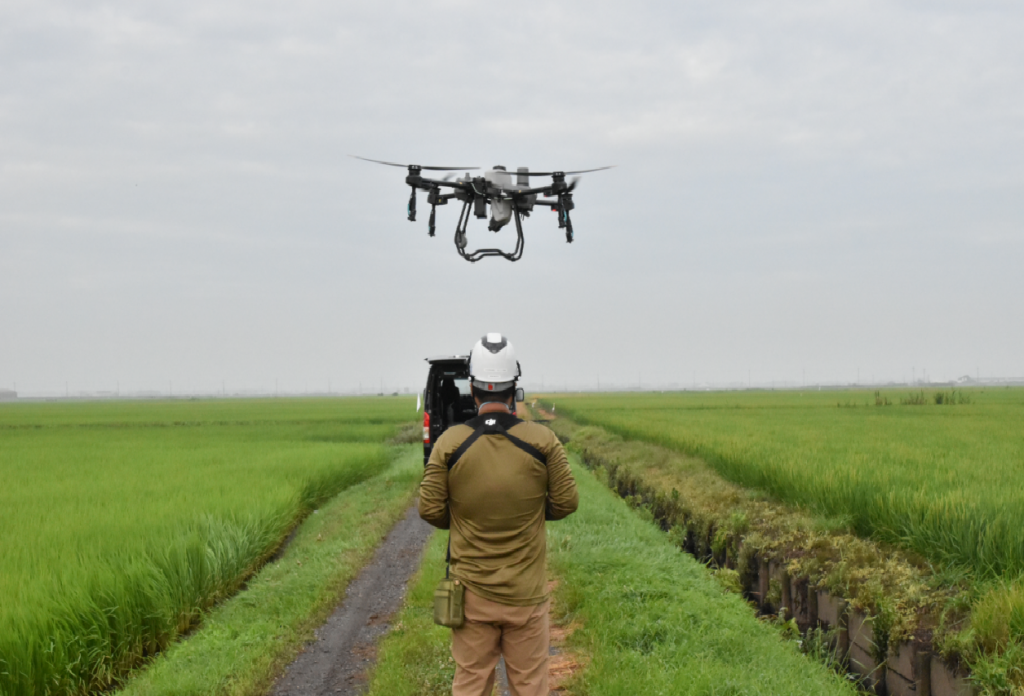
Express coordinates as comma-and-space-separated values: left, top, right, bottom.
420, 412, 579, 606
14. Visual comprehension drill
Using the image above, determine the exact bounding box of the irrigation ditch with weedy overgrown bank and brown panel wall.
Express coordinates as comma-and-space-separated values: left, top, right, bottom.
536, 408, 979, 696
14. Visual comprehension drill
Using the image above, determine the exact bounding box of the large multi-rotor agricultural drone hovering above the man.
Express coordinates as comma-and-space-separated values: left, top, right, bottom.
350, 155, 611, 263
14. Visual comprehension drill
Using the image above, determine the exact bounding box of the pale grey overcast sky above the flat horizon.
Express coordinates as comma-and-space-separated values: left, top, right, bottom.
0, 0, 1024, 395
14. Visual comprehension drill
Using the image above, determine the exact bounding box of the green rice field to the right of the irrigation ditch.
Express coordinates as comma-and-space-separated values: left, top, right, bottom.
556, 389, 1024, 577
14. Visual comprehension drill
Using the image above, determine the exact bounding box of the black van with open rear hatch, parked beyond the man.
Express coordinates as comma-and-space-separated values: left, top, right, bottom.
423, 355, 523, 467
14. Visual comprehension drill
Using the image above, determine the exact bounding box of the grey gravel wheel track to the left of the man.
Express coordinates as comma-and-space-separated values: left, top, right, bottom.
270, 505, 432, 696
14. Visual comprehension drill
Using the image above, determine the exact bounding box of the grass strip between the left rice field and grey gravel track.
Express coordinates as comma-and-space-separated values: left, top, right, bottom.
117, 445, 423, 696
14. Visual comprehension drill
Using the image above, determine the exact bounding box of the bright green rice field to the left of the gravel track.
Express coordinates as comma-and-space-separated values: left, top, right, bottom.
0, 397, 415, 696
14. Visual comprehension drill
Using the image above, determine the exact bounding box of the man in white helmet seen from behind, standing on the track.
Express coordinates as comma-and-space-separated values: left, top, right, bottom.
420, 334, 579, 696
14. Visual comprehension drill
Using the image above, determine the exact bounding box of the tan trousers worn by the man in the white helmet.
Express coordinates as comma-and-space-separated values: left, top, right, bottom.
452, 590, 550, 696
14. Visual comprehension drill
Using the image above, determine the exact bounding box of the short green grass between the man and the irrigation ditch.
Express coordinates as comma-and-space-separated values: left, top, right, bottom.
548, 455, 856, 696
